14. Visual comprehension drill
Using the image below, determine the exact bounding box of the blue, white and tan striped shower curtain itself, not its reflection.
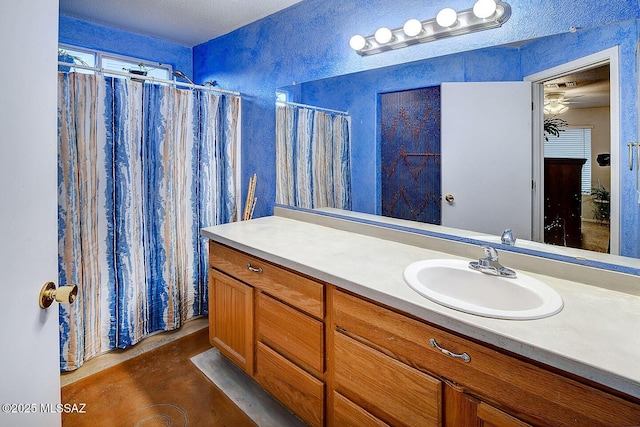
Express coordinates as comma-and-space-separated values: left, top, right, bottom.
58, 73, 240, 371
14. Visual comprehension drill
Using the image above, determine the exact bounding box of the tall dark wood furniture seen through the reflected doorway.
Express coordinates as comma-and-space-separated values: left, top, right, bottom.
544, 158, 587, 248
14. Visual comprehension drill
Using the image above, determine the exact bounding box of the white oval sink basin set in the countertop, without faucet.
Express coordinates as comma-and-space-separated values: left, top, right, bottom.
404, 259, 563, 320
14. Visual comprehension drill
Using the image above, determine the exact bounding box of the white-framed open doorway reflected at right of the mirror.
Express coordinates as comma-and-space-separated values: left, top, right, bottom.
525, 48, 619, 254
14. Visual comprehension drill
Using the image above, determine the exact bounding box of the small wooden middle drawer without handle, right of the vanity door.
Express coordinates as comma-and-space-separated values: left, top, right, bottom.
256, 293, 324, 378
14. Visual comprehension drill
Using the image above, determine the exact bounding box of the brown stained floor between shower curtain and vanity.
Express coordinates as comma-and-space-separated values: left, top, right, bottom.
61, 328, 256, 427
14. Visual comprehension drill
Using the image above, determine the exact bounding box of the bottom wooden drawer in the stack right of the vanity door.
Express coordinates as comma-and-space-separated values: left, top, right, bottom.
255, 342, 324, 426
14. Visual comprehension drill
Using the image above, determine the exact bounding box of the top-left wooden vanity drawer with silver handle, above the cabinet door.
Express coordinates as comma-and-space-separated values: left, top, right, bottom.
209, 241, 324, 319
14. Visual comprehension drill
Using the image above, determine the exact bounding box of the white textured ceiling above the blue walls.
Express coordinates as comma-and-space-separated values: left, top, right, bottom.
60, 0, 301, 46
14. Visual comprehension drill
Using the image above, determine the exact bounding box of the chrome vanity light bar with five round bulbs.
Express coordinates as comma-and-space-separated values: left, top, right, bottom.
349, 0, 511, 56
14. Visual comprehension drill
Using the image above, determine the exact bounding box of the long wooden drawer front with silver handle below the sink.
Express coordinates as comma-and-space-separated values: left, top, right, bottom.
334, 291, 640, 426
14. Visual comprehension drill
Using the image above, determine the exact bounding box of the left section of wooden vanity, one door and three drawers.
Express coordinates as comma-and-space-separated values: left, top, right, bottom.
209, 241, 325, 426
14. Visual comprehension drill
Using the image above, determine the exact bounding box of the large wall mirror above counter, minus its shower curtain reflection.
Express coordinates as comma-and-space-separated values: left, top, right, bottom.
279, 21, 640, 271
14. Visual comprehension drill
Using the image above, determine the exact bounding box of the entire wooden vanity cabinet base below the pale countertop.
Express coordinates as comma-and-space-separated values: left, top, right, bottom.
209, 242, 640, 427
